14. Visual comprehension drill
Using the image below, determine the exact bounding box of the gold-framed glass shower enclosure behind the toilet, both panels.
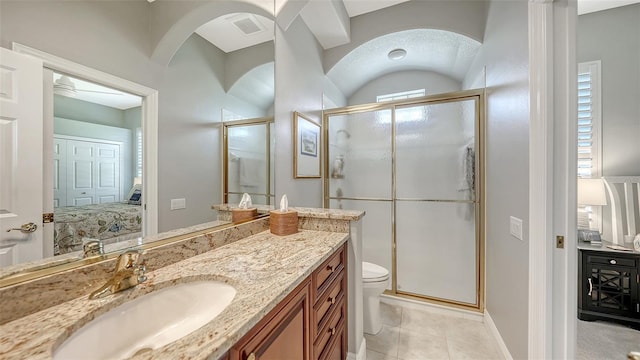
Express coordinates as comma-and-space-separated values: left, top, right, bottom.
323, 90, 484, 311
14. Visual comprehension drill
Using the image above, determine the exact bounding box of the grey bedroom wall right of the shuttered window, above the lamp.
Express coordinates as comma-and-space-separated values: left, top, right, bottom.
576, 4, 640, 176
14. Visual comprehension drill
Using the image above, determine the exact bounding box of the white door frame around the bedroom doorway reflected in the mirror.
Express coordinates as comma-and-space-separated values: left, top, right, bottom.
12, 42, 158, 241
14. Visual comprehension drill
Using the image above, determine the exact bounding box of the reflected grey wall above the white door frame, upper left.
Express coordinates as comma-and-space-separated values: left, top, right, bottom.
0, 0, 164, 88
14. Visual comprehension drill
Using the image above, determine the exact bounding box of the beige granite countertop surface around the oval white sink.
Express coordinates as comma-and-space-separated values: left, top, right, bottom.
0, 230, 348, 359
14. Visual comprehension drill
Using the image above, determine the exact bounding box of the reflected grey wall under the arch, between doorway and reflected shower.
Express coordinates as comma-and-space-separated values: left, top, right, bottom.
158, 36, 224, 232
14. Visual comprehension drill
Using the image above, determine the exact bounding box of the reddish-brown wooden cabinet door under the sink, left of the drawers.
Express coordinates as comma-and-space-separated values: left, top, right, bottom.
231, 281, 310, 360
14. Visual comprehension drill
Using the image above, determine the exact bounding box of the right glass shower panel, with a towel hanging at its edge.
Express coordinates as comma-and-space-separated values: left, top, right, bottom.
395, 98, 480, 305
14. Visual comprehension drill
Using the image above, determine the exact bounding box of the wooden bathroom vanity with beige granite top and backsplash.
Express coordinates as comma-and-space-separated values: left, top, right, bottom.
0, 209, 364, 360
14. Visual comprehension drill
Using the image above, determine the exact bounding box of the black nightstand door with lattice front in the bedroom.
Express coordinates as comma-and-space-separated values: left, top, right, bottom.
583, 256, 640, 318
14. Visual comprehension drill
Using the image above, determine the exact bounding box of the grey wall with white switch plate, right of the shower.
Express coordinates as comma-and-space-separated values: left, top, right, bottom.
464, 1, 530, 359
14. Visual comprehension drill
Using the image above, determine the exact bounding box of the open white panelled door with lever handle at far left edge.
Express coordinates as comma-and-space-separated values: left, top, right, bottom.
0, 48, 43, 266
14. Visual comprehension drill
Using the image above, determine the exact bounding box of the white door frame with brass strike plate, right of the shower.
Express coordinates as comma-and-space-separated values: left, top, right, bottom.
528, 0, 578, 359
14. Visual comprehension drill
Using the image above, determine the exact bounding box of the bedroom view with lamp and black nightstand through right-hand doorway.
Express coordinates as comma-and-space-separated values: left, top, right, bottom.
576, 1, 640, 359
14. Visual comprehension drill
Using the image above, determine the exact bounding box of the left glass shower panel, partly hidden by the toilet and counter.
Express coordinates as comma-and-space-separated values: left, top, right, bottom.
325, 109, 393, 270
